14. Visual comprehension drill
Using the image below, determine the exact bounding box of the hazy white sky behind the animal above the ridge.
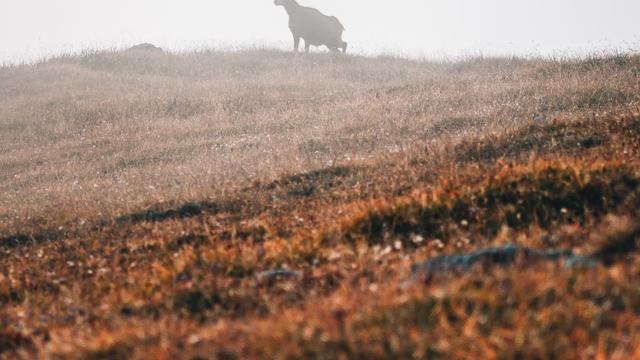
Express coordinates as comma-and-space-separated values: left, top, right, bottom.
0, 0, 640, 62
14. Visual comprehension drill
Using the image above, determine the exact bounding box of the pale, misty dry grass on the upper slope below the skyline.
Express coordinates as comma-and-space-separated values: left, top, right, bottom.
0, 51, 640, 226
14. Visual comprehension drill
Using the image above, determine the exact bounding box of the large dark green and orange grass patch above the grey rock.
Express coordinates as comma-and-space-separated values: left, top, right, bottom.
341, 166, 640, 245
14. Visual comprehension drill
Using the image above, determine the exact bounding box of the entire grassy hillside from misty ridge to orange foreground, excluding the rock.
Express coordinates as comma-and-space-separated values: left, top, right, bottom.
0, 50, 640, 359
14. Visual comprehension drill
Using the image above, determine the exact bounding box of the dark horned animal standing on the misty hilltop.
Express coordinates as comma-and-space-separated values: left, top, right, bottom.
274, 0, 347, 53
